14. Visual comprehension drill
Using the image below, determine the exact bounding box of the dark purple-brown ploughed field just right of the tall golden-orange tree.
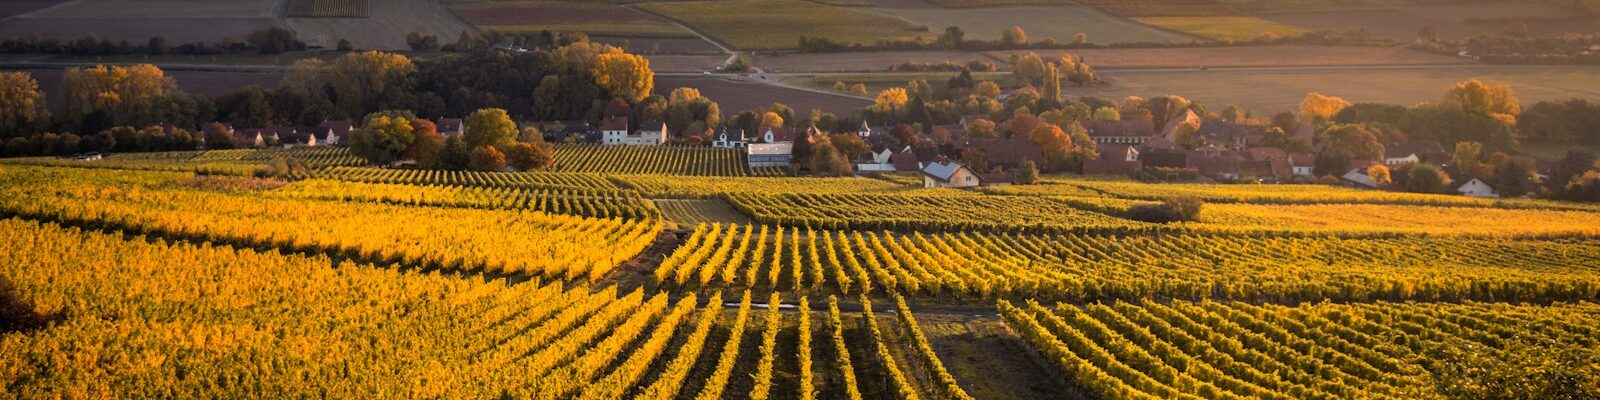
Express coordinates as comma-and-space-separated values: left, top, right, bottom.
656, 77, 870, 115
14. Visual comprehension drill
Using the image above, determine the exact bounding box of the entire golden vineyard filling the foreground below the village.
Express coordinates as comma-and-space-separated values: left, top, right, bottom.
0, 143, 1600, 400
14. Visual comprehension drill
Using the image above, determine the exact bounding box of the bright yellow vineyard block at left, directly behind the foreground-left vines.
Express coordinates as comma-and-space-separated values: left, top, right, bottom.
0, 166, 661, 280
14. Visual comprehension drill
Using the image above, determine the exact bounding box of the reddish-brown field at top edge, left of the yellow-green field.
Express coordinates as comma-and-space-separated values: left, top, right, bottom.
450, 2, 693, 37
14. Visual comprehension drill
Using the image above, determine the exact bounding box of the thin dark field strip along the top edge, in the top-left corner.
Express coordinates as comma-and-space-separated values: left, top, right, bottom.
14, 0, 278, 19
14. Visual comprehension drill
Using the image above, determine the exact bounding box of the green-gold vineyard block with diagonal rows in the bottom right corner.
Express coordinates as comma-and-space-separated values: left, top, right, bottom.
1000, 301, 1600, 400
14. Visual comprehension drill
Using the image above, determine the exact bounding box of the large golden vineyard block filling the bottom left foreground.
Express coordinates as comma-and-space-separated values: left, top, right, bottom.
0, 219, 979, 398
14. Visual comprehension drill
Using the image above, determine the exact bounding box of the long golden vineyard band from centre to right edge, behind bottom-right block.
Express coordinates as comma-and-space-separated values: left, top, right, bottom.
654, 224, 1600, 301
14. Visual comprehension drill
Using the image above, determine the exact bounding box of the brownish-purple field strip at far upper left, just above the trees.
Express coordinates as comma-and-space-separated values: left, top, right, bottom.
0, 18, 272, 43
